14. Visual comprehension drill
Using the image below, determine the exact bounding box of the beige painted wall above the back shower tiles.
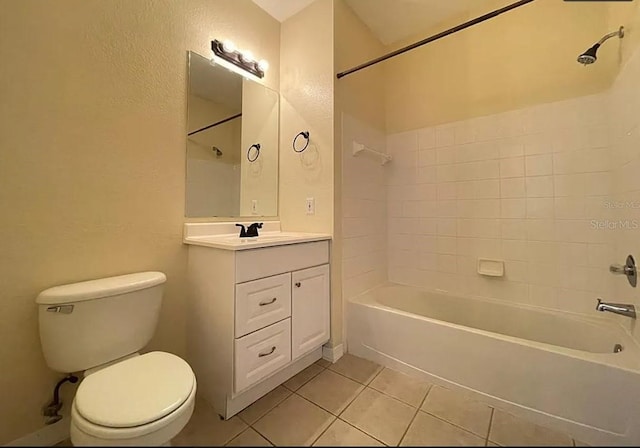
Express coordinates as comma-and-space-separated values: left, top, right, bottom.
384, 0, 635, 132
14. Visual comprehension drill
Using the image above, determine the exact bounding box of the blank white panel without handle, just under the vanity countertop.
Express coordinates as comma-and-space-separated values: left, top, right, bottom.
236, 241, 329, 283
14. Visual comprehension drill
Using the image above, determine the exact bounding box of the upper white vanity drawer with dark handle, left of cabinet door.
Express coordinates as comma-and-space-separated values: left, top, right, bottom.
235, 273, 291, 338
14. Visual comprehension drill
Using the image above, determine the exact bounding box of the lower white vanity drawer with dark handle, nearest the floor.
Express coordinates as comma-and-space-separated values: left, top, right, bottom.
234, 319, 291, 392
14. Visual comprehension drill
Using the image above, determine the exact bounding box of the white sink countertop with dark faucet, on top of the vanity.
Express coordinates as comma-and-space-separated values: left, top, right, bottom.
184, 232, 331, 250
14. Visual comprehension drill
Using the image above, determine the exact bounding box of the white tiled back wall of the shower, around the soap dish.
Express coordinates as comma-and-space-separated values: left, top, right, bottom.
387, 95, 613, 312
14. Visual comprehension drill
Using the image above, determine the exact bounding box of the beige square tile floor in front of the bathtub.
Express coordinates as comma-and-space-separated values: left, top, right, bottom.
173, 355, 580, 446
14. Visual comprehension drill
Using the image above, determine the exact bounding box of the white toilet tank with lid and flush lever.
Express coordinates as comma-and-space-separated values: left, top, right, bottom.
36, 272, 166, 373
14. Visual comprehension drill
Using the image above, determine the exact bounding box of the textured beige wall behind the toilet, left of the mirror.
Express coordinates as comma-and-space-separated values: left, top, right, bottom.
0, 0, 280, 444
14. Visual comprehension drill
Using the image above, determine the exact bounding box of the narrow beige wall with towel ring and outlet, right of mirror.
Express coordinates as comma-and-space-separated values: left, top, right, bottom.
279, 0, 342, 343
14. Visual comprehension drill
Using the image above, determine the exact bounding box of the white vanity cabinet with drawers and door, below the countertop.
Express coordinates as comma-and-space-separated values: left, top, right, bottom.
187, 241, 330, 418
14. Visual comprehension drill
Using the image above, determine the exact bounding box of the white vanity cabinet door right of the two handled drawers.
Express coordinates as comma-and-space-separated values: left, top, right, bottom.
291, 264, 330, 360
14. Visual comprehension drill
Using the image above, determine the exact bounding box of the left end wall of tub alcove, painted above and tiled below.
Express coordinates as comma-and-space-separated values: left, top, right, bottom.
332, 0, 386, 344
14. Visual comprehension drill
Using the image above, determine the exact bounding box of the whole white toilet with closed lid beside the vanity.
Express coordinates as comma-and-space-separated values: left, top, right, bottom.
36, 272, 196, 446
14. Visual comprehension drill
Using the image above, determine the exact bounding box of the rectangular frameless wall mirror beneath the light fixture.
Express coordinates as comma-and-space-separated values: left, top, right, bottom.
185, 51, 279, 218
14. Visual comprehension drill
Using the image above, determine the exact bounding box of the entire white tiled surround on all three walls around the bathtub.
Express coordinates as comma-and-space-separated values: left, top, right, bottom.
343, 46, 640, 325
